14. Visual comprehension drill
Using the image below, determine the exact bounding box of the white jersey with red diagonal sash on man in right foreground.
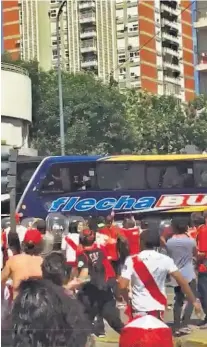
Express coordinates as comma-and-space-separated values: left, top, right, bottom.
121, 250, 178, 313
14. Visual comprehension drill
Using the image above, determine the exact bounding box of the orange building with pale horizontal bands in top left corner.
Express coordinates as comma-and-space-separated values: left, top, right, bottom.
1, 0, 20, 59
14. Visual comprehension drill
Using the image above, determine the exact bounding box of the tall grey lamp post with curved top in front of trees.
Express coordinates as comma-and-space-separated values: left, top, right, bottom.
56, 0, 67, 155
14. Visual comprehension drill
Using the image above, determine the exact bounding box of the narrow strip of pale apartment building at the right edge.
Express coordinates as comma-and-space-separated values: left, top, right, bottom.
194, 0, 207, 95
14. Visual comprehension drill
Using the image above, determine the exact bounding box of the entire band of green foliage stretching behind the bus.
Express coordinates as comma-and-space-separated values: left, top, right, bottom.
2, 53, 207, 155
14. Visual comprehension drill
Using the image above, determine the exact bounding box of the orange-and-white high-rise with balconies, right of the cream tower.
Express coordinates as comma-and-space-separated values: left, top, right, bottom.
116, 0, 195, 101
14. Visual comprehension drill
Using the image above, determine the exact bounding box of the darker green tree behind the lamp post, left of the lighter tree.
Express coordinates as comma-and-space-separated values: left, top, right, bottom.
30, 71, 128, 154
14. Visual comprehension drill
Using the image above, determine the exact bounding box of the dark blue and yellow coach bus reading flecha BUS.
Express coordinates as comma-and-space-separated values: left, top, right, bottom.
17, 154, 207, 223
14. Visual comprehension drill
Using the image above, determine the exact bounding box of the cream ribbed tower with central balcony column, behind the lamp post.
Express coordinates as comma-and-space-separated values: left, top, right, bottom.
50, 0, 116, 81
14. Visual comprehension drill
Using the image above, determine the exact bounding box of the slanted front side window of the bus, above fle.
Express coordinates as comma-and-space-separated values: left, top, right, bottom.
41, 162, 95, 193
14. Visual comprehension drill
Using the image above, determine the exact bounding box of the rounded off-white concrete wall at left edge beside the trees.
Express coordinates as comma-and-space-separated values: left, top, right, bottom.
1, 64, 32, 148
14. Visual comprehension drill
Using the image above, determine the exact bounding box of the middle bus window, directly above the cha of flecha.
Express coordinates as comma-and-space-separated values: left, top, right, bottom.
97, 162, 146, 190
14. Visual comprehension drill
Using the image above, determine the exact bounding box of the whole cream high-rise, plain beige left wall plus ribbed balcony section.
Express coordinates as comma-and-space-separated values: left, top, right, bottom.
19, 0, 117, 81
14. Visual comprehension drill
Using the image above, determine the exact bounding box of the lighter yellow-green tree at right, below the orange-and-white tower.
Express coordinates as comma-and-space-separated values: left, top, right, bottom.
125, 90, 207, 153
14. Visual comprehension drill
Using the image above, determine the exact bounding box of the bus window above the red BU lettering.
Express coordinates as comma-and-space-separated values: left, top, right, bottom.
147, 161, 194, 189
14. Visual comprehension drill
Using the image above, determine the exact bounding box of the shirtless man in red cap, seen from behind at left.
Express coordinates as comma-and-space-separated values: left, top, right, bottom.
1, 229, 43, 299
